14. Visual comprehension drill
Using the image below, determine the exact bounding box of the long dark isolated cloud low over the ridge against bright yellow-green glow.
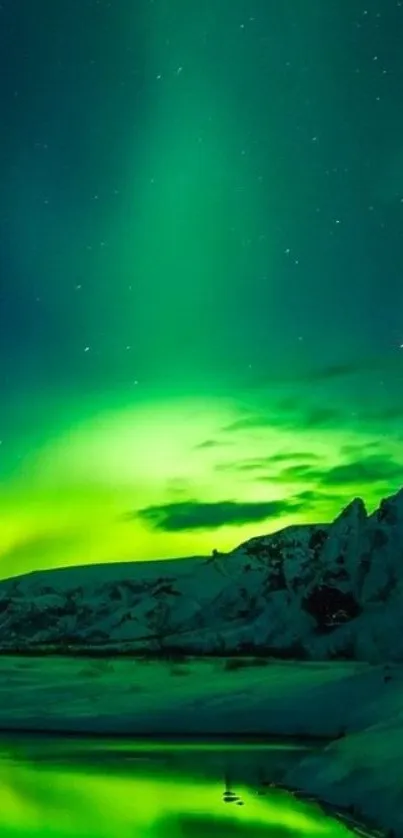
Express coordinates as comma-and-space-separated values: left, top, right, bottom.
134, 499, 298, 532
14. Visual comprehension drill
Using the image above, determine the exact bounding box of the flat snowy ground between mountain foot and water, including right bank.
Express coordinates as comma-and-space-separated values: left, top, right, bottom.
0, 657, 403, 836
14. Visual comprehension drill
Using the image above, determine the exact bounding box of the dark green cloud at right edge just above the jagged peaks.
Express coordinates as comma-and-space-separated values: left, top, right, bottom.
321, 455, 403, 486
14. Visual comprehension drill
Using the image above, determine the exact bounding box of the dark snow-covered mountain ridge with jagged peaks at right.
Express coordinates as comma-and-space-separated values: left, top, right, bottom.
0, 489, 403, 661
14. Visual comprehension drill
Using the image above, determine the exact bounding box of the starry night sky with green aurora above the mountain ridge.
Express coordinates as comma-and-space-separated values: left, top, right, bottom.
0, 0, 403, 576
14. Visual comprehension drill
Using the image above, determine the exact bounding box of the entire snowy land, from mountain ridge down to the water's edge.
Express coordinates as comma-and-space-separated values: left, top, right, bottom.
0, 490, 403, 838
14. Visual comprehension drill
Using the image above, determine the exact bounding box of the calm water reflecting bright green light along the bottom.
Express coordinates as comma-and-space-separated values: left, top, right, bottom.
0, 737, 349, 838
